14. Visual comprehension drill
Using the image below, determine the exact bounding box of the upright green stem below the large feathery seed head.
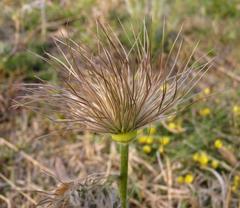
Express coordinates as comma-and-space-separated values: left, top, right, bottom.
119, 143, 129, 208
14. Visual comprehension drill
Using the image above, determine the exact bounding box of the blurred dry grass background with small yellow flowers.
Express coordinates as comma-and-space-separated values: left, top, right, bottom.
0, 0, 240, 208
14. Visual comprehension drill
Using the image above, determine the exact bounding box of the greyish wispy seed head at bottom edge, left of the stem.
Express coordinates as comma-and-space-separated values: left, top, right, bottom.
37, 174, 121, 208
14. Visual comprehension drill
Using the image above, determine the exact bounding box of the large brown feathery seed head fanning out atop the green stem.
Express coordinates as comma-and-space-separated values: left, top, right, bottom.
19, 20, 210, 140
